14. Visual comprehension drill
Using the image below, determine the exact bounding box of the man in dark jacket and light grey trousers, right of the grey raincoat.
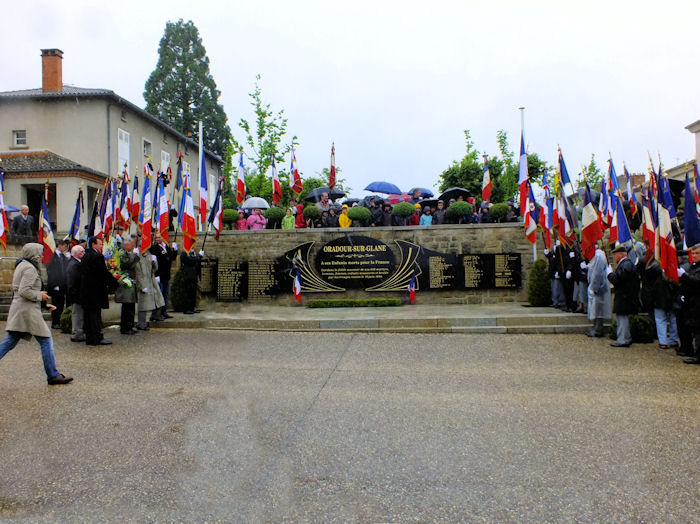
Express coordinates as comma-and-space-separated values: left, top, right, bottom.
606, 245, 639, 348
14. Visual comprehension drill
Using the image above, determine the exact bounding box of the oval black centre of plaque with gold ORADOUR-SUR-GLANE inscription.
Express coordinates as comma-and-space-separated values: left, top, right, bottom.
316, 235, 394, 288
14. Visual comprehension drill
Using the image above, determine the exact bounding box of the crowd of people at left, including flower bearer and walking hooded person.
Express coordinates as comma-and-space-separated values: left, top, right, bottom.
0, 221, 201, 385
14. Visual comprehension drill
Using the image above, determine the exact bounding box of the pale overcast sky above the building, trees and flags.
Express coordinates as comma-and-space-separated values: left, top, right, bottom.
0, 0, 700, 196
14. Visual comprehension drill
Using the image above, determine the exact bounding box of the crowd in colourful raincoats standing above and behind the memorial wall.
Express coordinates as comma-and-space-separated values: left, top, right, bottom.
234, 189, 519, 231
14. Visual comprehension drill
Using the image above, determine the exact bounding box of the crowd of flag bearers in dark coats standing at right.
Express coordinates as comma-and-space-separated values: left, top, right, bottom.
544, 241, 700, 364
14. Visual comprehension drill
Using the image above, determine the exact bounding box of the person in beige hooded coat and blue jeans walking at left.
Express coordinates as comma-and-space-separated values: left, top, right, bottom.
0, 243, 73, 386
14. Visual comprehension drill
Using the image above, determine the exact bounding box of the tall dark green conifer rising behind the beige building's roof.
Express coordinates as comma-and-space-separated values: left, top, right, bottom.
143, 19, 231, 157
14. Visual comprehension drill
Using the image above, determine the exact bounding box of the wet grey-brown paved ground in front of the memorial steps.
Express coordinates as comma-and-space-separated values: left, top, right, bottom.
0, 329, 700, 522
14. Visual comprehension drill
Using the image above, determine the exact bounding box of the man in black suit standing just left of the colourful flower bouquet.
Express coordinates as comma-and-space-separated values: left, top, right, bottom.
80, 237, 118, 346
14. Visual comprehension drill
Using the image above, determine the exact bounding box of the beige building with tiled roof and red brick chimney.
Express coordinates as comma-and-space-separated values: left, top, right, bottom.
0, 49, 223, 232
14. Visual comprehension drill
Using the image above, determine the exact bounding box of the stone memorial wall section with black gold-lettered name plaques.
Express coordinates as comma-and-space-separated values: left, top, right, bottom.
197, 223, 532, 306
